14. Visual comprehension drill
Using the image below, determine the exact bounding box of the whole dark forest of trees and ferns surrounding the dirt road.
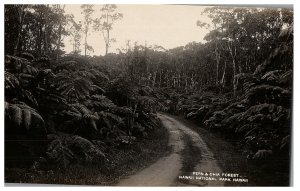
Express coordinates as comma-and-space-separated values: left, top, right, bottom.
4, 4, 294, 185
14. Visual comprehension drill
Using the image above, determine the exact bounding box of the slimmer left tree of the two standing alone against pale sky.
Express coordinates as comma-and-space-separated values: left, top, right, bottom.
81, 4, 94, 56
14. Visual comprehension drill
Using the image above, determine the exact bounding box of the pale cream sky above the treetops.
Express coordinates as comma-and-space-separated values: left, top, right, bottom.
64, 4, 209, 55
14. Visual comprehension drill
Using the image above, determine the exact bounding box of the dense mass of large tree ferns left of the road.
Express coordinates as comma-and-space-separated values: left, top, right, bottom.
5, 53, 161, 183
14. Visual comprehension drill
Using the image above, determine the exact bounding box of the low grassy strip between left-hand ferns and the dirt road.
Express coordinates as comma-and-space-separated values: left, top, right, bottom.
5, 121, 169, 186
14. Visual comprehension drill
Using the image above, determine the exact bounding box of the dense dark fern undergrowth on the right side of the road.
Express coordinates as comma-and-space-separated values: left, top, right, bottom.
158, 26, 293, 185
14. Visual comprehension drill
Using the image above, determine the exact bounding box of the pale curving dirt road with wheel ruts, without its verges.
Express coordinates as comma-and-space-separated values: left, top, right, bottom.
118, 114, 224, 186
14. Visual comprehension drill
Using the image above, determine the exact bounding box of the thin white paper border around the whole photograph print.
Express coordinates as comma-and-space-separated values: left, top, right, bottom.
0, 0, 300, 191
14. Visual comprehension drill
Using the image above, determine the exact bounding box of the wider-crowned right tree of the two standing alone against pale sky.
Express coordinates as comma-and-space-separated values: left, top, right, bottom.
94, 4, 123, 55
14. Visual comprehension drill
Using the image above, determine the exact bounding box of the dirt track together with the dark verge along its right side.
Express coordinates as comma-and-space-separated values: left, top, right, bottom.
118, 114, 251, 186
